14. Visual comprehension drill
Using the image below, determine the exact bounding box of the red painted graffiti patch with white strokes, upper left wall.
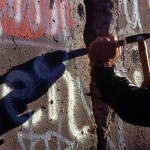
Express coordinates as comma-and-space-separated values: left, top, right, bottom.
0, 0, 73, 38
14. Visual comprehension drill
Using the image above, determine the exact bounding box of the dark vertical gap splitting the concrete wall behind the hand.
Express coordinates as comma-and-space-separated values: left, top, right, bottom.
84, 0, 113, 150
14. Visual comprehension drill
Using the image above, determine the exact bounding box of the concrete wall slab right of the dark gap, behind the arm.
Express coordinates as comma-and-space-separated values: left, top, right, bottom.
110, 0, 150, 150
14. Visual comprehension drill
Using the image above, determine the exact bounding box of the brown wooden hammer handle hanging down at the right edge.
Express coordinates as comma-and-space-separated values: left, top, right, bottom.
138, 41, 150, 81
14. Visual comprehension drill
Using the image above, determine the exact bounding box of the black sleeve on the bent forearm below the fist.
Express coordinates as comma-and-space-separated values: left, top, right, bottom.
94, 67, 150, 126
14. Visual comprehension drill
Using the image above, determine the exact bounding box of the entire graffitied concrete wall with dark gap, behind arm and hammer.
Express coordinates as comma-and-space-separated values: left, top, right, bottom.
0, 0, 150, 150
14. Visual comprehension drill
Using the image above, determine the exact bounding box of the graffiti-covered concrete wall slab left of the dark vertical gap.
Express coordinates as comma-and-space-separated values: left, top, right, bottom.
0, 0, 96, 150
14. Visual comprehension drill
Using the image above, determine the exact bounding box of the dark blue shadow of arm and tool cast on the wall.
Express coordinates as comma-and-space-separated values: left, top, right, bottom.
0, 49, 86, 145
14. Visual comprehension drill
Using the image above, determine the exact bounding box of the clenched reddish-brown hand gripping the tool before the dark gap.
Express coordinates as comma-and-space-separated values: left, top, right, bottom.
88, 35, 121, 68
